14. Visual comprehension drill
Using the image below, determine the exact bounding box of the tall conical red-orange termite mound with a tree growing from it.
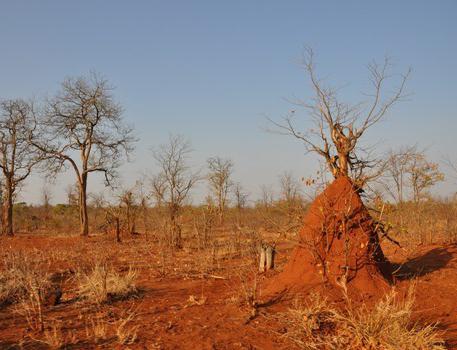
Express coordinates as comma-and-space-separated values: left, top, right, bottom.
263, 177, 392, 297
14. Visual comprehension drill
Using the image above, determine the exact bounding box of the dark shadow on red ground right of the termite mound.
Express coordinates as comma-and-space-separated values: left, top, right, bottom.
392, 246, 454, 281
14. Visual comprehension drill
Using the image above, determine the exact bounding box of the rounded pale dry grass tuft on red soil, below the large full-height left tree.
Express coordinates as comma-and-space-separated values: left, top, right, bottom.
76, 263, 138, 304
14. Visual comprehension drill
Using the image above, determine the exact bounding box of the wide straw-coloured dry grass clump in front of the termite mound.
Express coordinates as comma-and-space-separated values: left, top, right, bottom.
282, 291, 446, 350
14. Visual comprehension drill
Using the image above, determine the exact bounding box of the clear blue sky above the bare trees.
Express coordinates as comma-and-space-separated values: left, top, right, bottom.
0, 0, 457, 202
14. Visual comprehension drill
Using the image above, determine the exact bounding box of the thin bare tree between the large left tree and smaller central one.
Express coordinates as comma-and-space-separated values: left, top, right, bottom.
152, 135, 199, 248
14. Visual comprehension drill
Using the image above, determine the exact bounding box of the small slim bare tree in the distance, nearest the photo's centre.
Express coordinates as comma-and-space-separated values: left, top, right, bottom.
207, 157, 233, 223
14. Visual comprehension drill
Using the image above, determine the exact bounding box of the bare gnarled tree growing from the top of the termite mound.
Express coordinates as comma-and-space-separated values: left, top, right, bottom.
270, 49, 410, 188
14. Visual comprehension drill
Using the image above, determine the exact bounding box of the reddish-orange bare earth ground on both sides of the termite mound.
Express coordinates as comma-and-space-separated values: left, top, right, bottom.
0, 236, 457, 349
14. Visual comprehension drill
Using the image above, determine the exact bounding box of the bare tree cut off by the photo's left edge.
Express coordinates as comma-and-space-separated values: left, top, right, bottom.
0, 99, 43, 235
